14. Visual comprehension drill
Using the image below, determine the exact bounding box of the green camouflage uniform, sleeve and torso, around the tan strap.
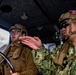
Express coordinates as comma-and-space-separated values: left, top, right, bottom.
32, 42, 76, 75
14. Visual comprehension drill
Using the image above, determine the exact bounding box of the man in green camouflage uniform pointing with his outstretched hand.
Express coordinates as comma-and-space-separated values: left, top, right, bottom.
20, 10, 76, 75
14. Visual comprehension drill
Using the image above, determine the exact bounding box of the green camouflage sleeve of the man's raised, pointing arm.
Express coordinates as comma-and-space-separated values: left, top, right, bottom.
32, 46, 51, 75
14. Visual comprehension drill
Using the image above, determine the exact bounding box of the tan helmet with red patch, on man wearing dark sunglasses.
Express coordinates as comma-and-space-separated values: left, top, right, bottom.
59, 10, 76, 22
